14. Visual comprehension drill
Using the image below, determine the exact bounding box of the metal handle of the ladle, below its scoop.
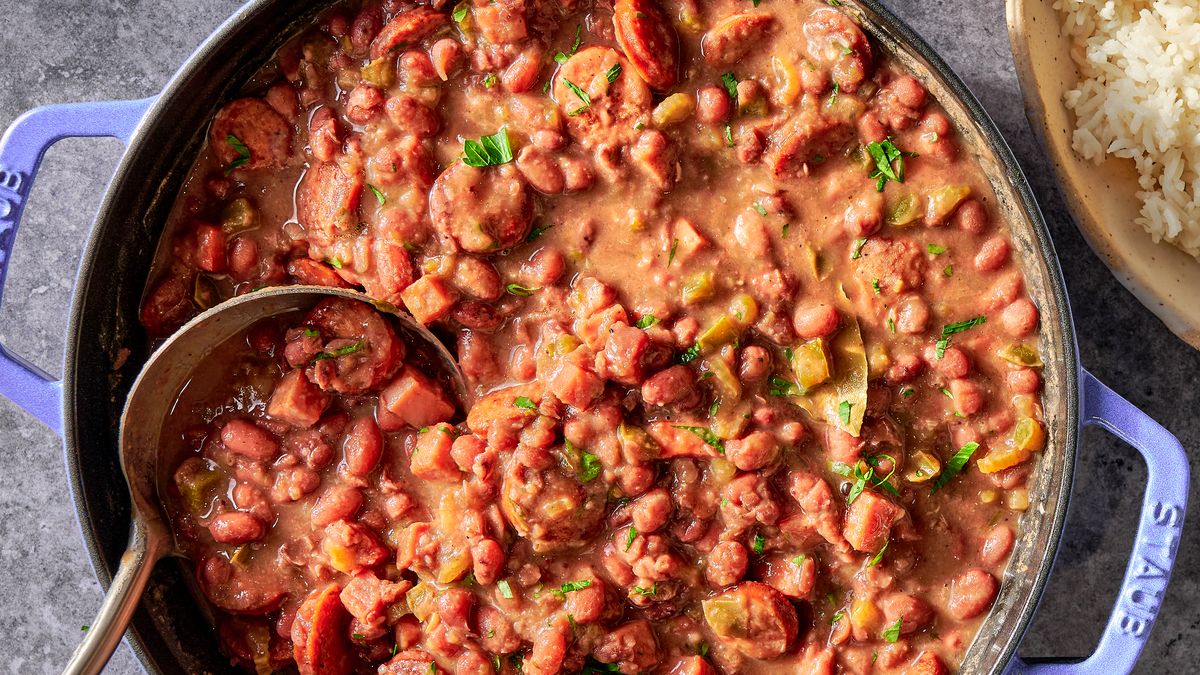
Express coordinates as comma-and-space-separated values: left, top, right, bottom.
62, 519, 166, 675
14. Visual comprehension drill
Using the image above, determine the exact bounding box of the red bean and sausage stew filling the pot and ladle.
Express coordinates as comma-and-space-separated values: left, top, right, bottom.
142, 0, 1045, 675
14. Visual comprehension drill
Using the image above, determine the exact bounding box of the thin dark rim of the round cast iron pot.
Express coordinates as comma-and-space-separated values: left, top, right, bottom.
62, 0, 1081, 673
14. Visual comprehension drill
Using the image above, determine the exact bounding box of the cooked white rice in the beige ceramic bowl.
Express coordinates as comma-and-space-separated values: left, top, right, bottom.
1055, 0, 1200, 258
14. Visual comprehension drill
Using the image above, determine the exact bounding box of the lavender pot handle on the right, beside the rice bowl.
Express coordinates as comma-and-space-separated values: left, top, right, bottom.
1007, 370, 1188, 675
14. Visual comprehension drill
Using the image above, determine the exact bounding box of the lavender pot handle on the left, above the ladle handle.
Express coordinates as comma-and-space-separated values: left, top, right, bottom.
0, 98, 155, 434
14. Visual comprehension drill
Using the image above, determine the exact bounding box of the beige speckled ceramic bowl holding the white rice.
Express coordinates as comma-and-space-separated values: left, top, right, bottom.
1008, 0, 1200, 348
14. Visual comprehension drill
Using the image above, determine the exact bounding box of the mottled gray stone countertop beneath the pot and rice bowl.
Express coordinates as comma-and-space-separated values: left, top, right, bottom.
0, 0, 1200, 674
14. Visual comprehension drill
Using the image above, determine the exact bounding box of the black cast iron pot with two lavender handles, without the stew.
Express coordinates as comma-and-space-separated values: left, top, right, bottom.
0, 0, 1188, 674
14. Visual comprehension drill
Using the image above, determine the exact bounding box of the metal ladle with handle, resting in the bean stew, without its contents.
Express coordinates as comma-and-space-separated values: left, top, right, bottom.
64, 286, 470, 675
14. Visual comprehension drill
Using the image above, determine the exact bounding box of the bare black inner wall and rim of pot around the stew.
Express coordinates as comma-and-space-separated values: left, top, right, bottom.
64, 0, 1078, 674
